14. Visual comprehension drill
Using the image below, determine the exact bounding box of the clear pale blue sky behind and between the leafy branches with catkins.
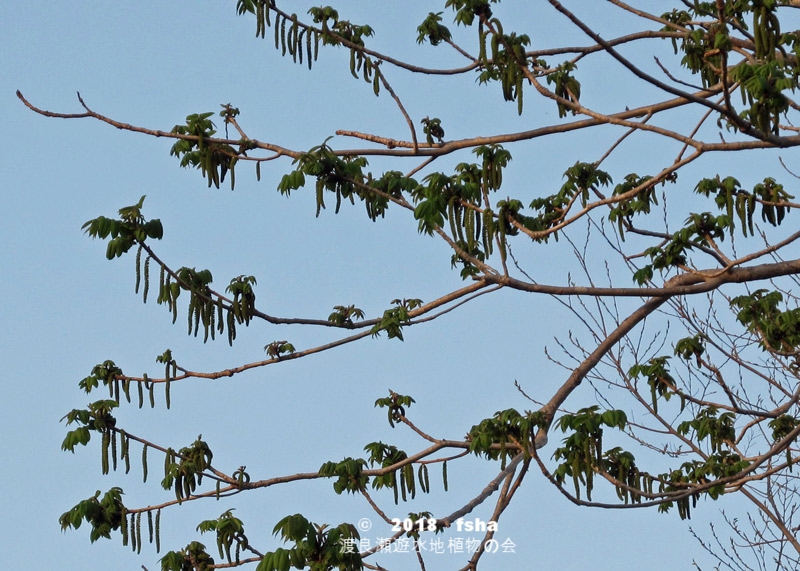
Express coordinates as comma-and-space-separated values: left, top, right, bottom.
0, 1, 792, 571
